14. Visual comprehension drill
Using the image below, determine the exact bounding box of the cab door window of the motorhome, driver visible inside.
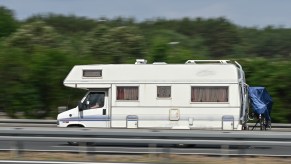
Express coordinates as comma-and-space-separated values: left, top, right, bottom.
85, 92, 105, 109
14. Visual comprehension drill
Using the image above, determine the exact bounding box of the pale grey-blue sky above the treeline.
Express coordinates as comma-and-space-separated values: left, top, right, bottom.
0, 0, 291, 28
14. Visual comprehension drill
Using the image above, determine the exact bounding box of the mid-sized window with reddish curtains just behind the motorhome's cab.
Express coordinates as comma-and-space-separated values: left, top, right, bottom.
116, 86, 138, 100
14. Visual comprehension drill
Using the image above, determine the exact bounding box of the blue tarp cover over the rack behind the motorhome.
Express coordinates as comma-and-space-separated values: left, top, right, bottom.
249, 87, 273, 120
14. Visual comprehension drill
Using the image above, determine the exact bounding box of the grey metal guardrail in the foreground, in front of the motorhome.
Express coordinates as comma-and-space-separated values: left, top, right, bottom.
0, 127, 291, 156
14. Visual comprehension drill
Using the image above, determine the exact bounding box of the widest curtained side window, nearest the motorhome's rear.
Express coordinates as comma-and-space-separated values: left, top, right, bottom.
191, 86, 228, 102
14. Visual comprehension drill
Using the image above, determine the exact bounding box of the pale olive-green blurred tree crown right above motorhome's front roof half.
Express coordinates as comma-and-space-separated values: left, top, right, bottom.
86, 25, 145, 63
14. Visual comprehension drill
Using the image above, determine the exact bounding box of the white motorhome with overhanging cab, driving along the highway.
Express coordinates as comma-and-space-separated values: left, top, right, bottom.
57, 59, 248, 130
